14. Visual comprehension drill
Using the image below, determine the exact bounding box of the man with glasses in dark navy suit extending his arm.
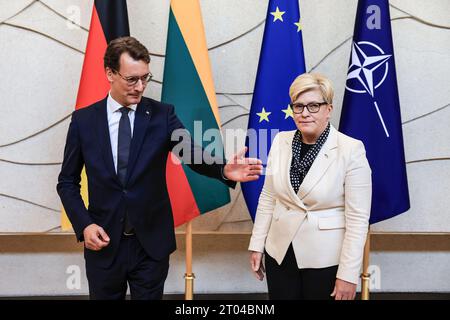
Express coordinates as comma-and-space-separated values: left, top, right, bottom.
57, 37, 262, 299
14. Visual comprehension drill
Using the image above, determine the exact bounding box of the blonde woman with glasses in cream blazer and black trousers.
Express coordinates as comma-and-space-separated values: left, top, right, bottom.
249, 73, 372, 300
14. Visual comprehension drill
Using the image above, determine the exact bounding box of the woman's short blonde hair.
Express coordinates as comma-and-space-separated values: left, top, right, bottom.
289, 73, 334, 104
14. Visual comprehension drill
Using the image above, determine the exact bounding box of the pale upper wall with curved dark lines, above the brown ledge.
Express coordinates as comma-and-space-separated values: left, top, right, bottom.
0, 0, 450, 232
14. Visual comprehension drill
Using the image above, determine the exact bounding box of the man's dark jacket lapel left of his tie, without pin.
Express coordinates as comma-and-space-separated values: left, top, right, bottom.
95, 97, 120, 184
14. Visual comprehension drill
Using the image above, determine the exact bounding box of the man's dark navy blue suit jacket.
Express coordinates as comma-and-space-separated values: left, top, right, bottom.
57, 97, 235, 267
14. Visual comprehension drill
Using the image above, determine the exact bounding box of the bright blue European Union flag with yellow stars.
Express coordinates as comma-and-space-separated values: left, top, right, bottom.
242, 0, 305, 220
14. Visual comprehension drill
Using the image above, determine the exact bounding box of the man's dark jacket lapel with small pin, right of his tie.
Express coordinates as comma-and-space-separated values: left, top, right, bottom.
127, 99, 152, 182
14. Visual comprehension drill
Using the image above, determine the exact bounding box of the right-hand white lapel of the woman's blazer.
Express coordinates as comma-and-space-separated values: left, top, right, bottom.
298, 126, 337, 200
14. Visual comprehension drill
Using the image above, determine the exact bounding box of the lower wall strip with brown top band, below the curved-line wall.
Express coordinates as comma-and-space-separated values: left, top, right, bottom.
0, 234, 450, 297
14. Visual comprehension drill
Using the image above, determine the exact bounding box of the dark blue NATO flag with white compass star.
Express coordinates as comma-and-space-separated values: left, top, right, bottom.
339, 0, 410, 223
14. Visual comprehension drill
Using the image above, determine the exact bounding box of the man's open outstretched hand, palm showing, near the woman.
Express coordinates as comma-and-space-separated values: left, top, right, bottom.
223, 147, 263, 182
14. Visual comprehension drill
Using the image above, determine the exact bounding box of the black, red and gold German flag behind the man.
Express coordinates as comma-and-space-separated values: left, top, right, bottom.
61, 0, 130, 231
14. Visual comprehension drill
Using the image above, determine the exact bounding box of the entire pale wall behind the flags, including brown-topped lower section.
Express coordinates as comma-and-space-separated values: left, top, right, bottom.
0, 0, 450, 296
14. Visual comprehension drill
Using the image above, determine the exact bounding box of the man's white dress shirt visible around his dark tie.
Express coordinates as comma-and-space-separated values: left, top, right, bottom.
106, 93, 137, 173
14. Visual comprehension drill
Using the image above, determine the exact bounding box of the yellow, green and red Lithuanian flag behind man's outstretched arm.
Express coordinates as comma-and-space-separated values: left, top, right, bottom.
162, 0, 230, 226
